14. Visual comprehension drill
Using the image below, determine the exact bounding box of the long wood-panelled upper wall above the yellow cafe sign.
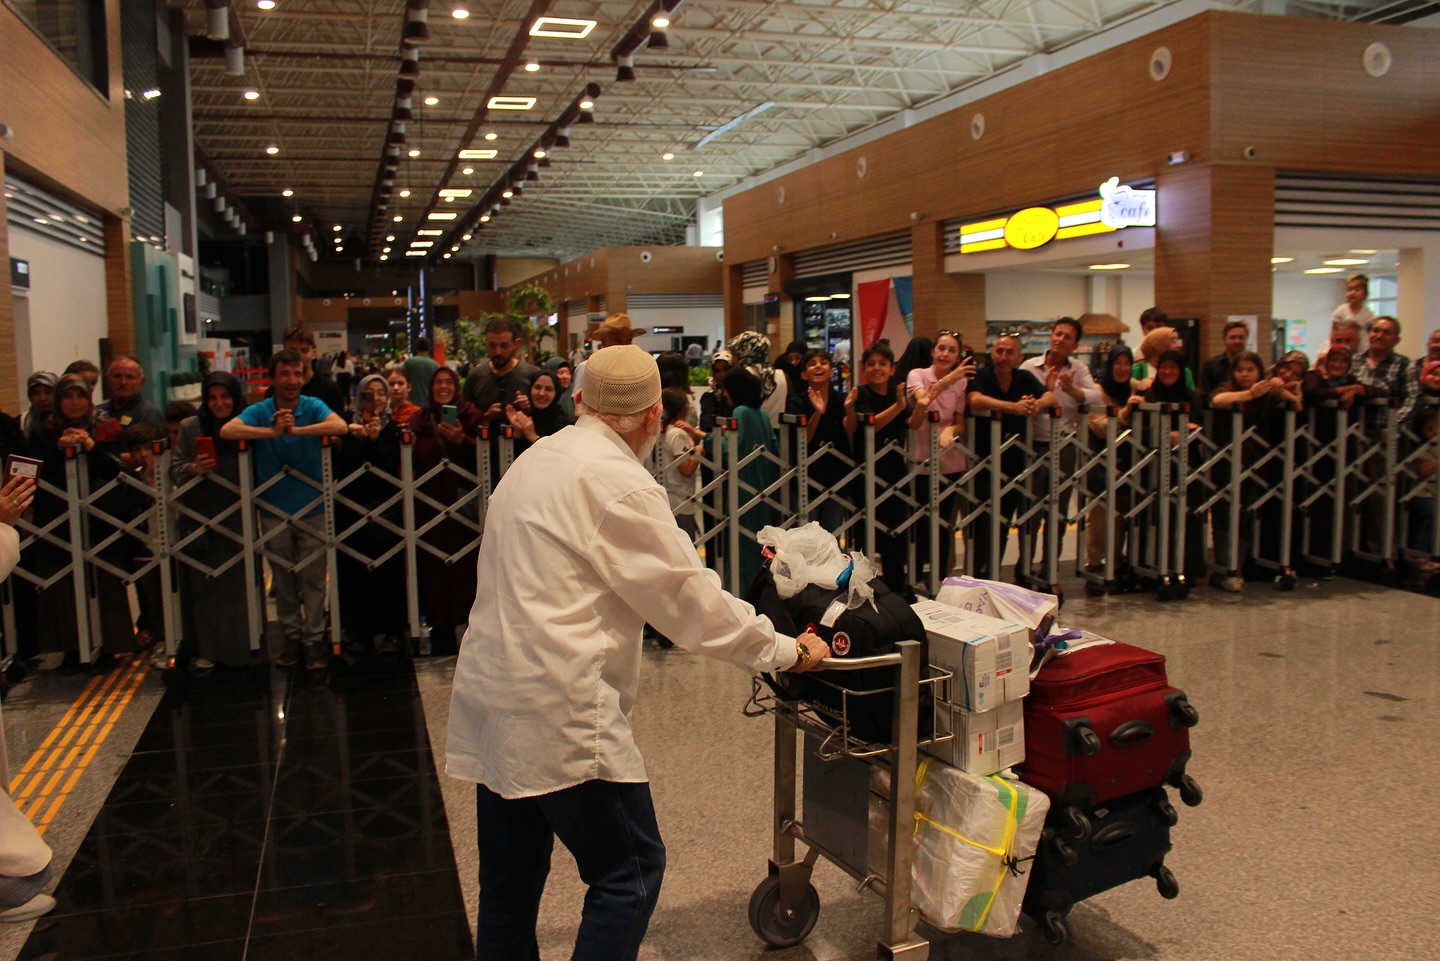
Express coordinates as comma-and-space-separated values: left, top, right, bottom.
724, 14, 1210, 264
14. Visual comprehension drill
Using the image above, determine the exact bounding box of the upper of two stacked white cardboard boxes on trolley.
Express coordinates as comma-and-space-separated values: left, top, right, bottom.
912, 601, 1031, 712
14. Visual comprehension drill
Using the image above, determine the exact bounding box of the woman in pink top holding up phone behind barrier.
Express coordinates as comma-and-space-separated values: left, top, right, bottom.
906, 330, 975, 581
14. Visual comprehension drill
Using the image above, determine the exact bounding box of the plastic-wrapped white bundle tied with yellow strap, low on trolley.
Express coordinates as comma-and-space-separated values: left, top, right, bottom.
912, 758, 1050, 938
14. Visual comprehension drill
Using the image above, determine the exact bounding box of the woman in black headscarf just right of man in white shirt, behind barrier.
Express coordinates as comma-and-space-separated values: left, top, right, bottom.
1084, 344, 1142, 596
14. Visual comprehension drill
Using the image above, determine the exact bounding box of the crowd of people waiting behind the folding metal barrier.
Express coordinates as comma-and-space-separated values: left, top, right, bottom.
8, 305, 1440, 671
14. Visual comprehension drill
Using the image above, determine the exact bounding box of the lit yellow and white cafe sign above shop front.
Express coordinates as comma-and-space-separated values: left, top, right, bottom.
960, 177, 1155, 254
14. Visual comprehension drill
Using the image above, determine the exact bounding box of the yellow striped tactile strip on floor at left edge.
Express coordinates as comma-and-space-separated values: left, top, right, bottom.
10, 654, 150, 834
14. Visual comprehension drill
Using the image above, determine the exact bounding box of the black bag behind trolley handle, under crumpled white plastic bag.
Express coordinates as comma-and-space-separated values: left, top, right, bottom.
746, 569, 935, 743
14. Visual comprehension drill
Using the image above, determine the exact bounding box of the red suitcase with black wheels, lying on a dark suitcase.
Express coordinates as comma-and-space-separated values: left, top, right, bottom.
1020, 643, 1202, 840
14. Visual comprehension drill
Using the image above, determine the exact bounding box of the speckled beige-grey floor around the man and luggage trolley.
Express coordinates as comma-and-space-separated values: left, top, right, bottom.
420, 570, 1440, 961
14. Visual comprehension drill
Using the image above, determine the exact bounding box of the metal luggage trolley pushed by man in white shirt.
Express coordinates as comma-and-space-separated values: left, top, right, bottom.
744, 641, 953, 961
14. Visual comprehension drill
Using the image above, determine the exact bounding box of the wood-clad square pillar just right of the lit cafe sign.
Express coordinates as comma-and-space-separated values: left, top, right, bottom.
1155, 164, 1274, 362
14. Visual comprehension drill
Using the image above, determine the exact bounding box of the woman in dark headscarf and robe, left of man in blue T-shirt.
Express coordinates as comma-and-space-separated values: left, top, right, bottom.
170, 370, 253, 670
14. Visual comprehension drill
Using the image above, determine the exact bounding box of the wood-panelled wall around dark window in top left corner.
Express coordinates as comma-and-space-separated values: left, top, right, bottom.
0, 0, 130, 215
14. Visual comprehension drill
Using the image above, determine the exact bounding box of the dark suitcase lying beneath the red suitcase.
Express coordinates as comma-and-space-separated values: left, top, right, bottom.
1021, 788, 1179, 944
